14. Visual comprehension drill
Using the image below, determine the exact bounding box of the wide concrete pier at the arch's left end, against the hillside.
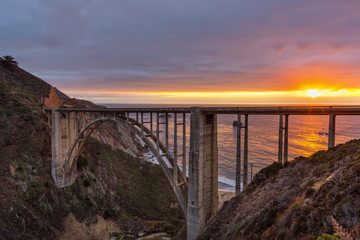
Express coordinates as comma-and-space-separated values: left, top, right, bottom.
51, 109, 77, 187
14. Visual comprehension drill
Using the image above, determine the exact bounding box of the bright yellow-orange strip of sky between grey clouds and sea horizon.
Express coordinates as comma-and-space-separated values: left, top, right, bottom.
65, 89, 360, 104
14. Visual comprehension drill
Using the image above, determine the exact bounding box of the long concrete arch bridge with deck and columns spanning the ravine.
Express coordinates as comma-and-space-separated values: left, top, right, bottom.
45, 106, 360, 240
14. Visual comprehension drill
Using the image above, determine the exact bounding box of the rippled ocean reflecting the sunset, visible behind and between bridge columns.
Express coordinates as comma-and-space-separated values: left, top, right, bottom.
102, 104, 360, 191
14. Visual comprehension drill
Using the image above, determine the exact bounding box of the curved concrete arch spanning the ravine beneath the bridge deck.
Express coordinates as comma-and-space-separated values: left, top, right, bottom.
61, 116, 187, 217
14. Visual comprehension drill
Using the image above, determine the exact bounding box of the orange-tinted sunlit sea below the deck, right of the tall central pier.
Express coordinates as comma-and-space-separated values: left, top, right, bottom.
218, 115, 360, 189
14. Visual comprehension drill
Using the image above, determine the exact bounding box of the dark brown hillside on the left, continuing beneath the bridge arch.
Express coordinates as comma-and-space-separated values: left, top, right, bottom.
0, 59, 184, 239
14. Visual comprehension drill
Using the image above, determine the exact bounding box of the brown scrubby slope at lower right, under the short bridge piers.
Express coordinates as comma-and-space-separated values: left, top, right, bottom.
198, 140, 360, 240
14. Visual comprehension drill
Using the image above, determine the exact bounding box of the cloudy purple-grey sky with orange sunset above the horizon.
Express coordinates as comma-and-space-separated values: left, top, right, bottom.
0, 0, 360, 104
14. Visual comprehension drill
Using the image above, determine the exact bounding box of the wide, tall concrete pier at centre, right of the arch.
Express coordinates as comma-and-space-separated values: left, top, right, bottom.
186, 107, 218, 240
